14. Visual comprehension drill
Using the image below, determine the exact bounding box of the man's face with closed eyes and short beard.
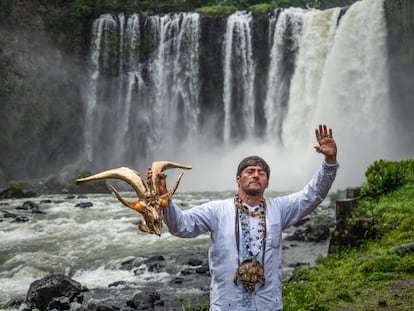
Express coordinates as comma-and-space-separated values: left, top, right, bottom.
236, 165, 269, 195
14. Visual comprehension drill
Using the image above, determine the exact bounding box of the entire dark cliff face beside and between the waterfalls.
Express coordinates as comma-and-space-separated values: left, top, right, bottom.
0, 0, 414, 186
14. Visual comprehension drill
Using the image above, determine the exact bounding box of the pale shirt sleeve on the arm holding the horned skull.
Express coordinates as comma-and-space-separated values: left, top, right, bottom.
164, 200, 214, 238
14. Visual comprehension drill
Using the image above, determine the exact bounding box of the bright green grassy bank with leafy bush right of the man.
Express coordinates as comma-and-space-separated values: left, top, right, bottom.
283, 160, 414, 311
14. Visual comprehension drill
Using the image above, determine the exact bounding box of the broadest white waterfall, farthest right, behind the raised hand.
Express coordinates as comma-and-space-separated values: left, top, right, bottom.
316, 0, 392, 186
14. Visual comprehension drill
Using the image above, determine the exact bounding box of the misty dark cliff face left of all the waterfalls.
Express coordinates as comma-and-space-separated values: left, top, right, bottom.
0, 1, 85, 184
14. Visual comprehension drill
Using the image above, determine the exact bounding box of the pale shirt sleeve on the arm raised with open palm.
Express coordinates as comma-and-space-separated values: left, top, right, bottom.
278, 161, 339, 229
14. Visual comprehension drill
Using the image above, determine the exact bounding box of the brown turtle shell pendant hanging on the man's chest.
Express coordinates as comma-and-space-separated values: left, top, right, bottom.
234, 256, 265, 292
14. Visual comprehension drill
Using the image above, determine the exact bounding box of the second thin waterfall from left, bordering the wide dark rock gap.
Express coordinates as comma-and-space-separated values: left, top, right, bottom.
146, 13, 200, 154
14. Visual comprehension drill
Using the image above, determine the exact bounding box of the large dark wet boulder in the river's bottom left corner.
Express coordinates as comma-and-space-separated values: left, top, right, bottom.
26, 274, 82, 310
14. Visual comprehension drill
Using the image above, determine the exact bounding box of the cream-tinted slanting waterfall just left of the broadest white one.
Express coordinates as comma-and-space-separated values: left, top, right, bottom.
282, 9, 340, 152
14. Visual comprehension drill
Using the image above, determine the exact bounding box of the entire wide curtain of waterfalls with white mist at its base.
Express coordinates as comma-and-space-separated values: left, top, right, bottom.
85, 0, 405, 190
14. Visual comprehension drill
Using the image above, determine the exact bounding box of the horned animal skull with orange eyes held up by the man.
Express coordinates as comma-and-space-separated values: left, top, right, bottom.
76, 161, 191, 236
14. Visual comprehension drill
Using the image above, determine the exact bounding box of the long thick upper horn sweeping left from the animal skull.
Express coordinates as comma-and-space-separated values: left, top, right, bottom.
76, 167, 147, 200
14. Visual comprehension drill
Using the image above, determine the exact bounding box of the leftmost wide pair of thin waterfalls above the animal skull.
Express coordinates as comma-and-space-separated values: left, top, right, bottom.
85, 13, 200, 167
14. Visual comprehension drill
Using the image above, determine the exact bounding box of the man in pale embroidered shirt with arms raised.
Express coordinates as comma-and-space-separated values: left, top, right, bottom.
148, 125, 339, 311
